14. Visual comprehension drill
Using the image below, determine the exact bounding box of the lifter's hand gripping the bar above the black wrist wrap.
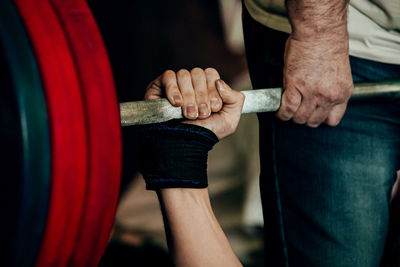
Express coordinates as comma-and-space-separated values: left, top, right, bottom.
145, 68, 244, 140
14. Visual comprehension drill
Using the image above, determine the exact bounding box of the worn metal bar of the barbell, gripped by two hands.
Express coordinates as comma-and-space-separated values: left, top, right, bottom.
119, 81, 400, 126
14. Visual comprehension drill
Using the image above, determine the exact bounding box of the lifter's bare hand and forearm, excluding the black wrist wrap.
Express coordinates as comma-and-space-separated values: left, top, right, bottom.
145, 68, 244, 267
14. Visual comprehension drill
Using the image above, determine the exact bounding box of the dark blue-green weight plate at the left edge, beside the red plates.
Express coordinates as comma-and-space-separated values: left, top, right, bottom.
0, 0, 51, 266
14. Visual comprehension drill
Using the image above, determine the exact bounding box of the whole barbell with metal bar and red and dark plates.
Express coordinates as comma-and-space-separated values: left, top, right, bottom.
0, 0, 400, 266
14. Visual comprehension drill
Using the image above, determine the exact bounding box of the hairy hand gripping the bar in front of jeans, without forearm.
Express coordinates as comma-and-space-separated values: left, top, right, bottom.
277, 36, 353, 127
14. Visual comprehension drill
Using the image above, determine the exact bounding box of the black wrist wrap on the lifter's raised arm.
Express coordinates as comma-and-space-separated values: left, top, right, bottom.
139, 121, 218, 190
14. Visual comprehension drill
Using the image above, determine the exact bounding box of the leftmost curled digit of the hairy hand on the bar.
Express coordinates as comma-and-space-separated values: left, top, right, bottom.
276, 88, 302, 121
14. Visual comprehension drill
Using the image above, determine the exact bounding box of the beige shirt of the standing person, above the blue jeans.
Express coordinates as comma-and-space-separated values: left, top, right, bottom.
244, 0, 400, 65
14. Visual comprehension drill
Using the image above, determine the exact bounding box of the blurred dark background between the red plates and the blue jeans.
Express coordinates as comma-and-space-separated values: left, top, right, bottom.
88, 0, 264, 266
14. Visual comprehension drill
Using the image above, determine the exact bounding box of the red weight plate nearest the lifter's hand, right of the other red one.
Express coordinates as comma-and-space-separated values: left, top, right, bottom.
50, 0, 122, 266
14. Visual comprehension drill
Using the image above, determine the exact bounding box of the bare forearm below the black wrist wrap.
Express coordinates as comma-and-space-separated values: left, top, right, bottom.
158, 188, 242, 267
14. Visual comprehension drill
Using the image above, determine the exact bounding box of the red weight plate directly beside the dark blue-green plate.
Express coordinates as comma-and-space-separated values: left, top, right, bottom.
14, 0, 88, 267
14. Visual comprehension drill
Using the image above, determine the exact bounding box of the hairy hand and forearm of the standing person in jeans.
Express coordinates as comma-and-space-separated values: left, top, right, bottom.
277, 0, 354, 127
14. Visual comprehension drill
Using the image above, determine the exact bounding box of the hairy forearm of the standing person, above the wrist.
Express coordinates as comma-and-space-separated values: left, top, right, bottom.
286, 0, 349, 40
